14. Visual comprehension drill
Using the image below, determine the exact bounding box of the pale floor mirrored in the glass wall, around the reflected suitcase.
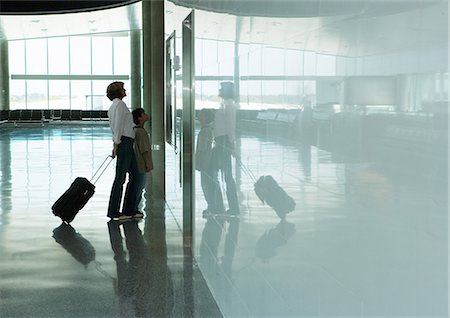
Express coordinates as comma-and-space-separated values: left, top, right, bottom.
189, 134, 448, 317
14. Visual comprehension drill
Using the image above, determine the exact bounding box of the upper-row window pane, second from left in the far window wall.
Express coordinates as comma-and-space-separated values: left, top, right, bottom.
25, 39, 47, 74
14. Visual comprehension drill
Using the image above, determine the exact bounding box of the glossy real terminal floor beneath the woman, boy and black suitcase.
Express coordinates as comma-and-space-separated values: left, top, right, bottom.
0, 125, 221, 317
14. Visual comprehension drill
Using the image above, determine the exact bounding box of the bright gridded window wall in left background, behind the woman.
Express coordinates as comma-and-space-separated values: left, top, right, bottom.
9, 32, 130, 110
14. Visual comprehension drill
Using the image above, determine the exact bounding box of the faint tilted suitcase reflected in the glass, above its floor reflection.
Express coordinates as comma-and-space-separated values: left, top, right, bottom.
255, 176, 295, 218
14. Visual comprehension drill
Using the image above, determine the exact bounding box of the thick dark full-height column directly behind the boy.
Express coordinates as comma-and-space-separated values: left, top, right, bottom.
142, 0, 165, 213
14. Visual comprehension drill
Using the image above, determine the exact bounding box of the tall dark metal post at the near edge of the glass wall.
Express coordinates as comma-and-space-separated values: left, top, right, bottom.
182, 11, 195, 245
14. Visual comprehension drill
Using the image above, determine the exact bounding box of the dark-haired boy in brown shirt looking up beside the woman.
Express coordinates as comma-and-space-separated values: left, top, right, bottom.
131, 108, 153, 217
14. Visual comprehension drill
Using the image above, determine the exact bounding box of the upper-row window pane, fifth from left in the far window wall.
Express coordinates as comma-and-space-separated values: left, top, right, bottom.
92, 36, 112, 75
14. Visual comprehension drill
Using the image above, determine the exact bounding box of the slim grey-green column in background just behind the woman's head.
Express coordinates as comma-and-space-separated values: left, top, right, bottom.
130, 30, 142, 109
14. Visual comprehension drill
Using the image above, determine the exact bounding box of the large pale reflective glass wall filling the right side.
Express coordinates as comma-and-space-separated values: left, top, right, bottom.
167, 1, 448, 317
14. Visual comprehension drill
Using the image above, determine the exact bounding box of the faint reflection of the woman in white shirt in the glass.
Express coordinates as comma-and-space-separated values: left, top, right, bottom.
212, 82, 240, 214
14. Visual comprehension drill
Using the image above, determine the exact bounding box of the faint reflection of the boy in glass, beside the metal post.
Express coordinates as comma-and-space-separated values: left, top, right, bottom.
195, 108, 224, 214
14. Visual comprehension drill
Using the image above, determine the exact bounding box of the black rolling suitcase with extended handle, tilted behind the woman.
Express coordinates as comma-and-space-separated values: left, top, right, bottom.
52, 156, 112, 223
